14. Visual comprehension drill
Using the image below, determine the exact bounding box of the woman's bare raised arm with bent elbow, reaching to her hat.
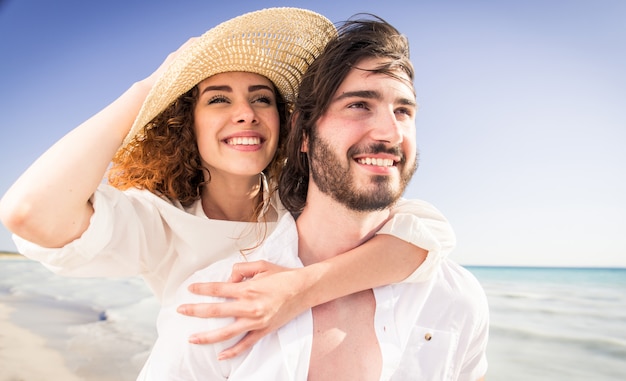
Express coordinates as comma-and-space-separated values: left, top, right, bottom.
0, 83, 149, 247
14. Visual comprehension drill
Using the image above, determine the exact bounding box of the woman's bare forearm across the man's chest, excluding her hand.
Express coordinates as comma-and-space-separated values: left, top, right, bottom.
294, 235, 427, 307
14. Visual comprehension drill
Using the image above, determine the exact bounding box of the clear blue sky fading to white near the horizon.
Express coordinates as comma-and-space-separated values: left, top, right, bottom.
0, 0, 626, 267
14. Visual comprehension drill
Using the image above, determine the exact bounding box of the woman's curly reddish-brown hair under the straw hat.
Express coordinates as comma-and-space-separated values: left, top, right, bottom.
108, 86, 288, 206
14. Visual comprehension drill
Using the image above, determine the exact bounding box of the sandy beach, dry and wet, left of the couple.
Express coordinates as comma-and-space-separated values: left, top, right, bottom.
0, 253, 142, 381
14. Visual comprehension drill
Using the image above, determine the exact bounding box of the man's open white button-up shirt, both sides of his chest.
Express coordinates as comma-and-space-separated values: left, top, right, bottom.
138, 213, 489, 381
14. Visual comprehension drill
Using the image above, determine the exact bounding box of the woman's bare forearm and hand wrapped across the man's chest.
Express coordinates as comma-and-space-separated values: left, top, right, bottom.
173, 234, 427, 359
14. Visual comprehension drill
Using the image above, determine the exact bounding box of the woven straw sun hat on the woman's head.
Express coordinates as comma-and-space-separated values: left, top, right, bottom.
122, 8, 337, 146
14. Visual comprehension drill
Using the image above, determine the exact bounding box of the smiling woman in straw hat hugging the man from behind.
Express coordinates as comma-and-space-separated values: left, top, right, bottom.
0, 8, 454, 357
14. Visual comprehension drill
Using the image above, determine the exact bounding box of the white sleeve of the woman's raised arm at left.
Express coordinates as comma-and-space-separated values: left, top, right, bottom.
13, 184, 165, 277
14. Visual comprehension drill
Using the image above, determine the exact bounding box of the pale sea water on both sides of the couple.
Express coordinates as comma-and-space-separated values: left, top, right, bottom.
0, 259, 626, 381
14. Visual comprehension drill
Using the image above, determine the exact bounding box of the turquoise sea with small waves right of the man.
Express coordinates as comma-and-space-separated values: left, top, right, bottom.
468, 267, 626, 381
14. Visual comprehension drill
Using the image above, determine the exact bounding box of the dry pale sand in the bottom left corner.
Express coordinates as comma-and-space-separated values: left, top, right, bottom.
0, 304, 81, 381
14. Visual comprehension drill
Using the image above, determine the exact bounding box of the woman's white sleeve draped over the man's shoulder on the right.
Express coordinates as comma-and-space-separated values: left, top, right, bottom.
377, 199, 456, 283
